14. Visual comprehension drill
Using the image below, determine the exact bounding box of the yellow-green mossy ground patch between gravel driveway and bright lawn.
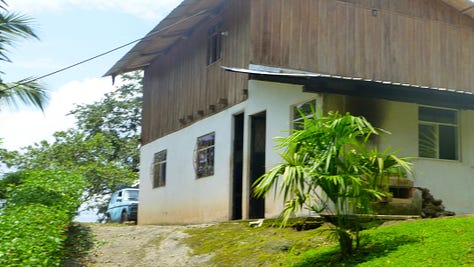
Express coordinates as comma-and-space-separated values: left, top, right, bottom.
186, 221, 333, 266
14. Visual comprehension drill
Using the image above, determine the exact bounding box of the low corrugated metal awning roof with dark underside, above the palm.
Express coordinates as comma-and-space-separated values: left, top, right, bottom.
222, 65, 474, 110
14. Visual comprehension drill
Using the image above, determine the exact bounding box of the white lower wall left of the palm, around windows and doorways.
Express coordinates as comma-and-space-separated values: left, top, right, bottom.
138, 81, 317, 224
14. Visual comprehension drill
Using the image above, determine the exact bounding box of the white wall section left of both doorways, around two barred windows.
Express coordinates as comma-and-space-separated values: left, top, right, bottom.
138, 104, 243, 224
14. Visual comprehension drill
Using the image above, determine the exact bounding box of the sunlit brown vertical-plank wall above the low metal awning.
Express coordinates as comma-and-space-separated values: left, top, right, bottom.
250, 0, 474, 92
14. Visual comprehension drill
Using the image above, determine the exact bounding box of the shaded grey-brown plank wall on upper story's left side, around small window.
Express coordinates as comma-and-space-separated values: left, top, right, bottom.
142, 0, 250, 144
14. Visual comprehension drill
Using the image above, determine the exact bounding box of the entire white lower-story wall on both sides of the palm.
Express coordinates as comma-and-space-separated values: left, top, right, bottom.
138, 80, 474, 224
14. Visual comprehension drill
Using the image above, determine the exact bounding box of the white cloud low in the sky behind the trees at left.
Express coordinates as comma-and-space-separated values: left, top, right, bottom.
0, 78, 115, 150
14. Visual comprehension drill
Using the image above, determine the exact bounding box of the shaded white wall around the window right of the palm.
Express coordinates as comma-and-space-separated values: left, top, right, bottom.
381, 101, 474, 214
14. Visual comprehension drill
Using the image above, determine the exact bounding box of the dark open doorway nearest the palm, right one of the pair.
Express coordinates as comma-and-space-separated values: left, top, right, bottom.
249, 112, 267, 219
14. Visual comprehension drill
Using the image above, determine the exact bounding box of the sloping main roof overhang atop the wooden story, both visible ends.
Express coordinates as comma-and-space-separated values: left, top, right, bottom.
105, 0, 474, 76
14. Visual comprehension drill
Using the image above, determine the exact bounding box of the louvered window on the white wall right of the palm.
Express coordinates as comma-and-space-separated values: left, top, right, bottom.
418, 107, 459, 160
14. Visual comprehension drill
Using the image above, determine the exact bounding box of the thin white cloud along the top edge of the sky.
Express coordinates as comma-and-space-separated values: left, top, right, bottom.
8, 0, 181, 20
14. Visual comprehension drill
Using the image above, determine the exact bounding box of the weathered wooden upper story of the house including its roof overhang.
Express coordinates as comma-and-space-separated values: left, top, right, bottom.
107, 0, 474, 144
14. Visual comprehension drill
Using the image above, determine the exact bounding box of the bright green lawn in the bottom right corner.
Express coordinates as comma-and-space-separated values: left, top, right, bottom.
294, 217, 474, 267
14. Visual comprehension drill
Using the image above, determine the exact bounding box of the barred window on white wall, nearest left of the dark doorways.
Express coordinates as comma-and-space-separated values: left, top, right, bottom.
196, 133, 215, 178
